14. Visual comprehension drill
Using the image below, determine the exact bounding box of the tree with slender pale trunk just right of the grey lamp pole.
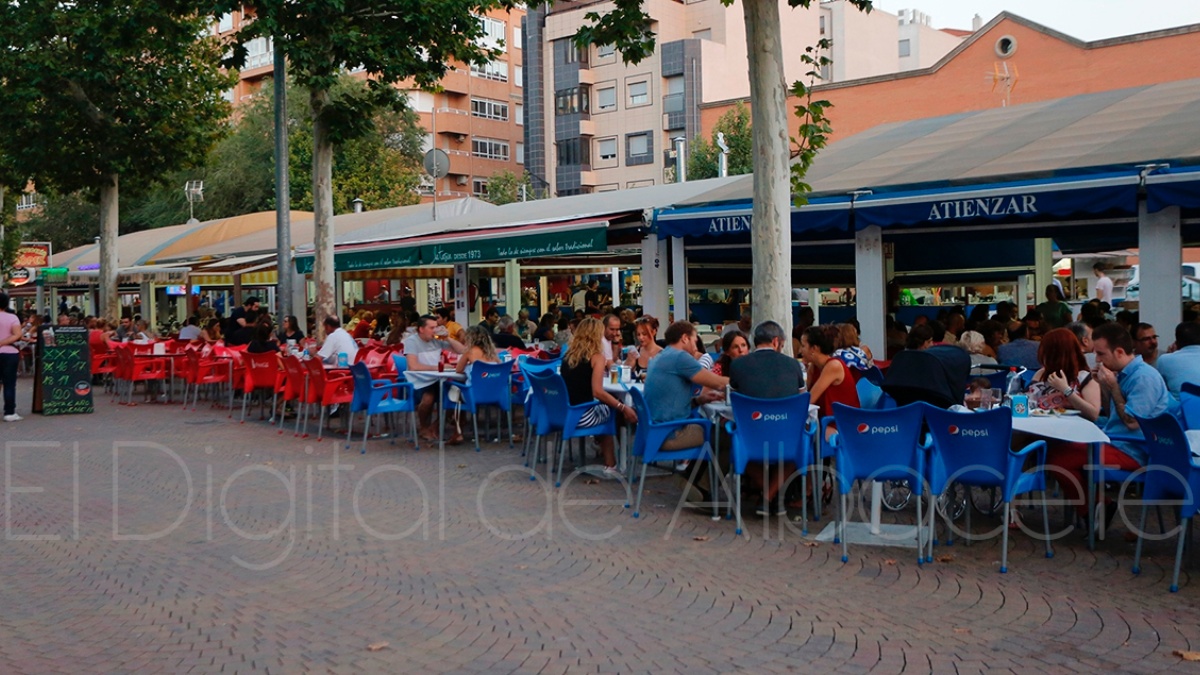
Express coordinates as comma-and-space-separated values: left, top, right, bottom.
215, 0, 515, 324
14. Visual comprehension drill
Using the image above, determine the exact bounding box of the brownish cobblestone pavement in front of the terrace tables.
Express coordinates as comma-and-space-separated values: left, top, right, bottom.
0, 378, 1200, 673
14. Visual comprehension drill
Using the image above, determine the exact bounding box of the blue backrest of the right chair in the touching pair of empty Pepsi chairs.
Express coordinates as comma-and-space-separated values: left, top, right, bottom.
925, 404, 1013, 491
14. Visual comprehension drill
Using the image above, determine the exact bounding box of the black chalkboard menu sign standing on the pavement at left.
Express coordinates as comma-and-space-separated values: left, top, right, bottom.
34, 325, 96, 414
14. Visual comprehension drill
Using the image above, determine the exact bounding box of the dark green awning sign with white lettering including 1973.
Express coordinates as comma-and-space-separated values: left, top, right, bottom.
421, 227, 608, 264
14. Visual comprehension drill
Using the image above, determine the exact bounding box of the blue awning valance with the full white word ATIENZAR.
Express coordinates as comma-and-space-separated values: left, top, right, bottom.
854, 173, 1139, 229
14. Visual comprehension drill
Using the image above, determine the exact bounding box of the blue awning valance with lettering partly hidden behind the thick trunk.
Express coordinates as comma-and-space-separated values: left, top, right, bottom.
654, 197, 850, 237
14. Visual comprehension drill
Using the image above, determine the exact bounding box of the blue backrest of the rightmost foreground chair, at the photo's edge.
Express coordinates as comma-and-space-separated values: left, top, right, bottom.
1134, 412, 1200, 518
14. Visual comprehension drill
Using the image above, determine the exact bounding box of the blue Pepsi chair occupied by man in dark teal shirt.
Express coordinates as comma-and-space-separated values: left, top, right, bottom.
726, 392, 816, 534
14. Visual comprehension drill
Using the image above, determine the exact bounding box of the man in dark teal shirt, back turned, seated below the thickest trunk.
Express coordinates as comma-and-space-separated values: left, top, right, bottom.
724, 321, 811, 515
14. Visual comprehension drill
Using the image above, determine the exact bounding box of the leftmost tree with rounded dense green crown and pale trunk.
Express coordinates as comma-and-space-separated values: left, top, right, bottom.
0, 0, 233, 316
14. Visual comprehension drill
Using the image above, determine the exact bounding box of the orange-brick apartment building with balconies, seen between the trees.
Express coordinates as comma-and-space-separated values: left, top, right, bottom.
214, 8, 524, 199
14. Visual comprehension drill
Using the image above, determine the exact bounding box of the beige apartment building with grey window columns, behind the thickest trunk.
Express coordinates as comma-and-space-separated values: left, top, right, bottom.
524, 0, 962, 196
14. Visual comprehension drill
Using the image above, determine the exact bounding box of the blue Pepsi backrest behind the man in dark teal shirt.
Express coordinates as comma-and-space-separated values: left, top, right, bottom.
730, 392, 812, 473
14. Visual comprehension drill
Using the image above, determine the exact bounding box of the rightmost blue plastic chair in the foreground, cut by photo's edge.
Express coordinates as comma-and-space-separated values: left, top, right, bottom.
1133, 413, 1200, 593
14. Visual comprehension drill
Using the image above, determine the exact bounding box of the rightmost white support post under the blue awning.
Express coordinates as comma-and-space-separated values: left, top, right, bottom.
1138, 201, 1183, 333
